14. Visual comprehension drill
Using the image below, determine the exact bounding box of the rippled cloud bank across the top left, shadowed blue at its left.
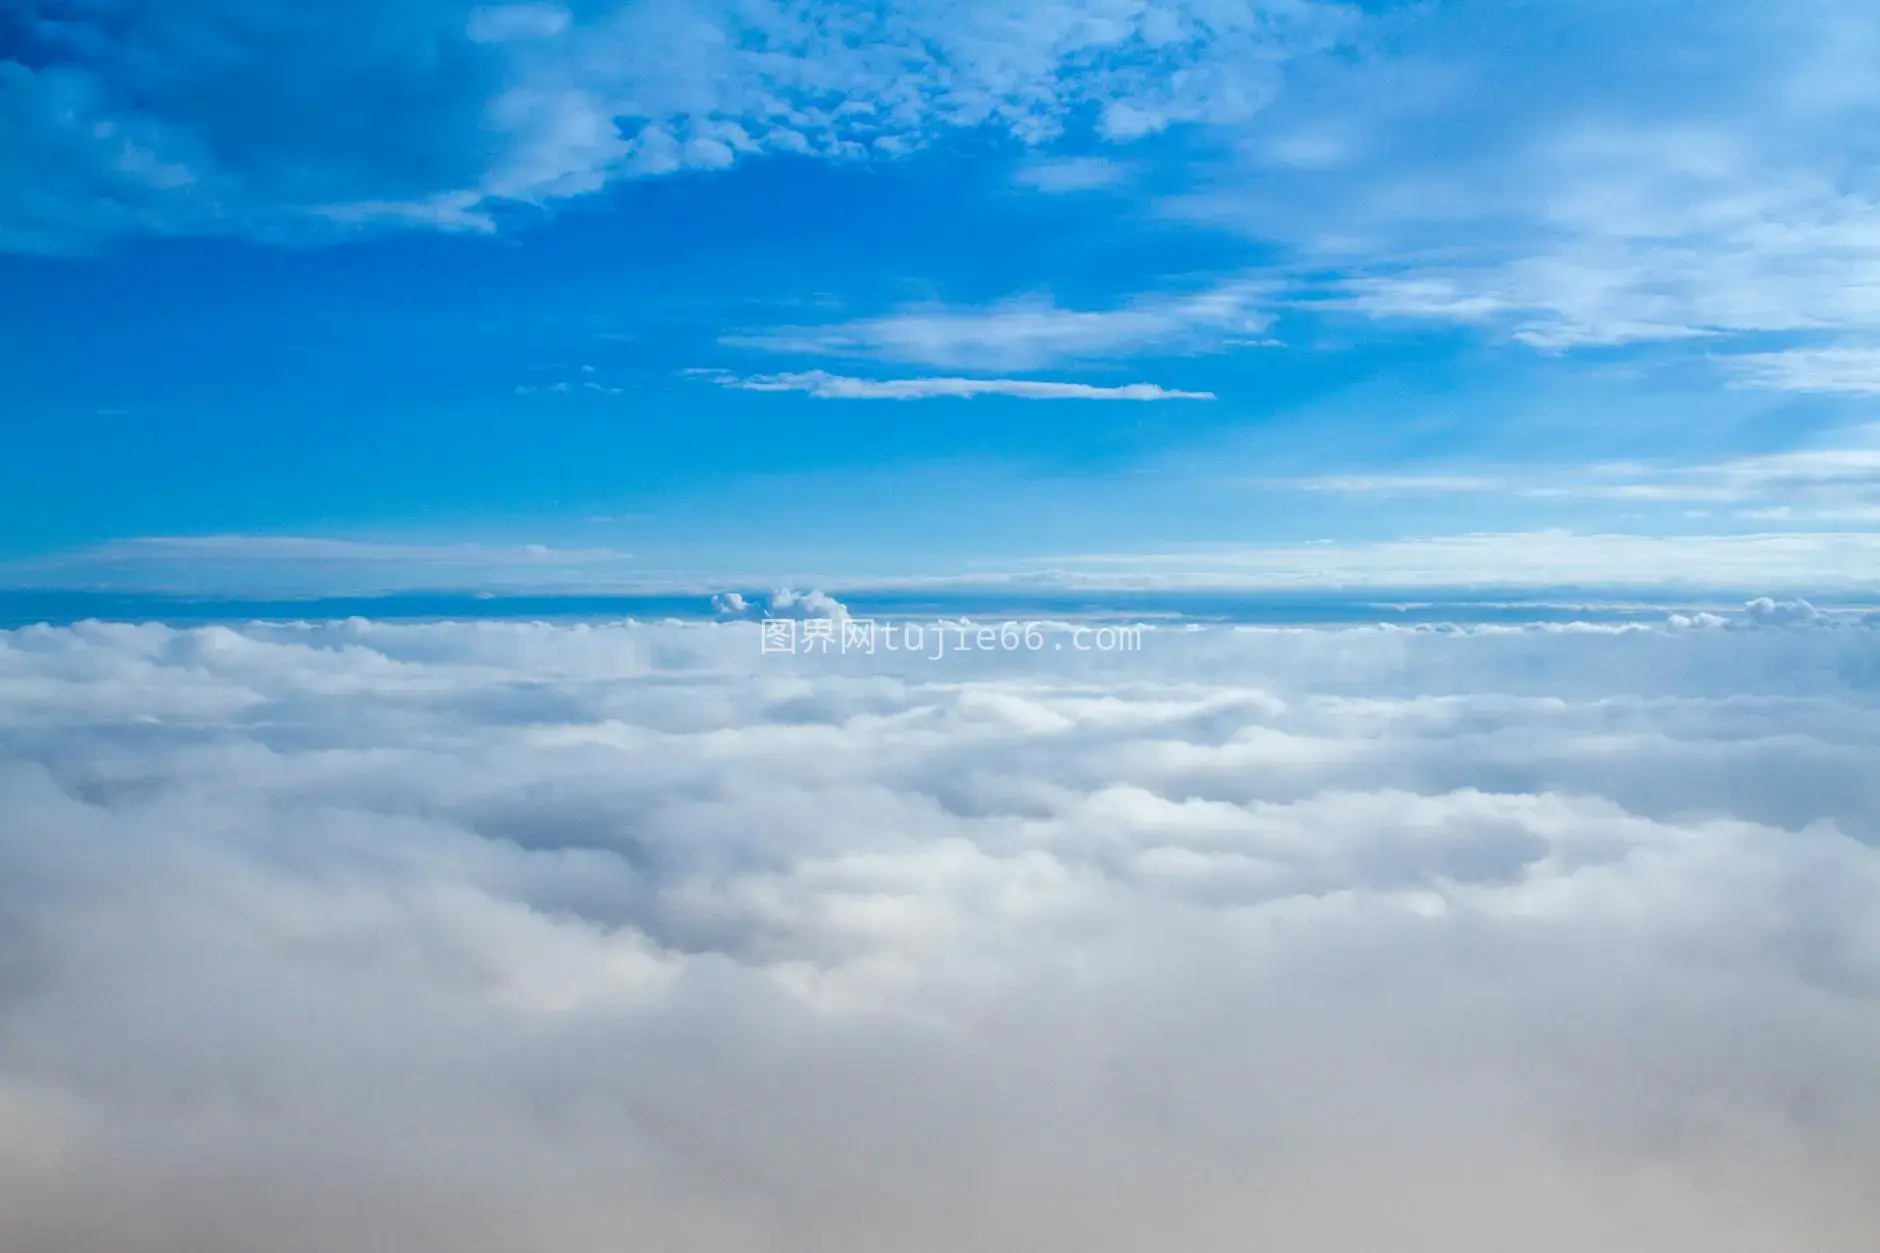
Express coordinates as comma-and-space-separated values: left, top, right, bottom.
0, 0, 1346, 250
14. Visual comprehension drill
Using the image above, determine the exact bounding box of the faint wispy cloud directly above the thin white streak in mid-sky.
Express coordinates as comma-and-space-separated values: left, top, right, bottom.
722, 280, 1273, 371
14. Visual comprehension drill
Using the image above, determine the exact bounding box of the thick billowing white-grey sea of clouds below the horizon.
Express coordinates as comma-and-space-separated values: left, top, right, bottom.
0, 608, 1880, 1253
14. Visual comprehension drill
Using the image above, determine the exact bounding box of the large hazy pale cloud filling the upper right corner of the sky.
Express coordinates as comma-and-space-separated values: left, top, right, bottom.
1167, 0, 1880, 355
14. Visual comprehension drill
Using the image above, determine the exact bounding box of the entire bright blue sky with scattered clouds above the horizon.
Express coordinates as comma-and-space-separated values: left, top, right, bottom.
0, 0, 1880, 591
